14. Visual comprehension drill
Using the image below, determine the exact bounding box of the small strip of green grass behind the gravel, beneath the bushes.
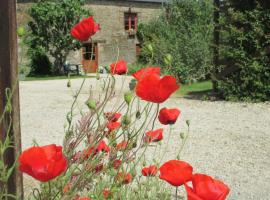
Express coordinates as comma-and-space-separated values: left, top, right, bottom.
176, 81, 213, 96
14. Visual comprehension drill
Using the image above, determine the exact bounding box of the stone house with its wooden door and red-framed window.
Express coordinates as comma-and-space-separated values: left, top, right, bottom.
17, 0, 168, 72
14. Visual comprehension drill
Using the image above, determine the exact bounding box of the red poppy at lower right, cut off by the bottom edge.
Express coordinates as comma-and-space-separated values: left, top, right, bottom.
185, 174, 230, 200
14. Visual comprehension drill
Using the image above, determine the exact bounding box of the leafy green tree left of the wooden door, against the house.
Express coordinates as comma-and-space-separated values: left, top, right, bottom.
27, 0, 90, 74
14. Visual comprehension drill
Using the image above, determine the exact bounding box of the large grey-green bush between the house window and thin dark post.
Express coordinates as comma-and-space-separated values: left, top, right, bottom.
138, 0, 213, 82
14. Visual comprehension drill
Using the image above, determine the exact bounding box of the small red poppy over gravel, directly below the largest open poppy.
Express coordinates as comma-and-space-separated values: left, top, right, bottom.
158, 108, 181, 125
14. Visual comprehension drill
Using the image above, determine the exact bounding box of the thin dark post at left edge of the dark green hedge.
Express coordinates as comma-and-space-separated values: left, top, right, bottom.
212, 0, 220, 92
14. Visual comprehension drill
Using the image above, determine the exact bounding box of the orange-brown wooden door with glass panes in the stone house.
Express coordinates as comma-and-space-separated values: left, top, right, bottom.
82, 43, 98, 73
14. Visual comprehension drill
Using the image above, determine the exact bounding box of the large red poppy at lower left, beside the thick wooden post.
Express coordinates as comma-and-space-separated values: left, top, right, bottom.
19, 144, 67, 182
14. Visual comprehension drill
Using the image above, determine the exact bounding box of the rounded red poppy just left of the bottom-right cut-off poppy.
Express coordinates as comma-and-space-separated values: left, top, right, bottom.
159, 160, 193, 186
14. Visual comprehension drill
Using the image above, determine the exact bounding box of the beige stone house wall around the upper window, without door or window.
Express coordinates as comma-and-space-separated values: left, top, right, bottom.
87, 0, 161, 65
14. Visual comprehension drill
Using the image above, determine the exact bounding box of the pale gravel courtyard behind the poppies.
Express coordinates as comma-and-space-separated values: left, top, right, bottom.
20, 78, 270, 200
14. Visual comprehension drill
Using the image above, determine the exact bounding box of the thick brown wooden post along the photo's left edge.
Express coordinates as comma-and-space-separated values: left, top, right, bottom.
0, 0, 23, 199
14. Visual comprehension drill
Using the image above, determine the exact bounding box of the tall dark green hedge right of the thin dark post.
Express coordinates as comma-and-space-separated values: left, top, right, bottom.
218, 0, 270, 101
